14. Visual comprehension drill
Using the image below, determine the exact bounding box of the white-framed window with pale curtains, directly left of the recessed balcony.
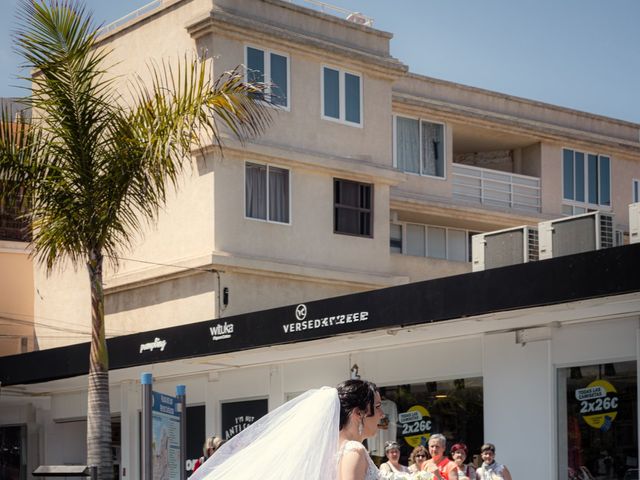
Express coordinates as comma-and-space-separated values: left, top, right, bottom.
395, 116, 445, 178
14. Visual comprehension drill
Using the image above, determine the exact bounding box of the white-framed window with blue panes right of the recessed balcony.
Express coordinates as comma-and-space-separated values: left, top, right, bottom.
562, 148, 611, 215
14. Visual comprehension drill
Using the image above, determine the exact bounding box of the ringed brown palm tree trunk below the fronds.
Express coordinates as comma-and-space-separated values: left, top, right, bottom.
87, 249, 113, 480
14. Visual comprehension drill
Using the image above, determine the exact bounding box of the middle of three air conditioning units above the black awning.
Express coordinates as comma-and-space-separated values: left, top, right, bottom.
538, 211, 615, 260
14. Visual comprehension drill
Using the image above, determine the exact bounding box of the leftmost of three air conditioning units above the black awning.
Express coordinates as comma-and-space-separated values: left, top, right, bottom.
471, 225, 538, 272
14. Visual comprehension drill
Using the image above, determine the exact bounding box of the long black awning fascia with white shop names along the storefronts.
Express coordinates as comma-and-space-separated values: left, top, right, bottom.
0, 244, 640, 386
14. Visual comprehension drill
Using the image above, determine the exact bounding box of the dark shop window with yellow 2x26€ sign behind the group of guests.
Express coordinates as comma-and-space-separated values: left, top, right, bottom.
368, 377, 484, 465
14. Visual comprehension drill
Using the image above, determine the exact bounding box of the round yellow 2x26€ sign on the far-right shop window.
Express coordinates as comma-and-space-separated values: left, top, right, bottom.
575, 380, 618, 432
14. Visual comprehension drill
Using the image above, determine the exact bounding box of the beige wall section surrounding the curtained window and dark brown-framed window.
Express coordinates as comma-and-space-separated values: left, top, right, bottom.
215, 159, 389, 271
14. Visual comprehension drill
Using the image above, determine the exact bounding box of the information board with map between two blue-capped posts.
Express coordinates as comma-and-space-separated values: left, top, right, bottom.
151, 392, 183, 480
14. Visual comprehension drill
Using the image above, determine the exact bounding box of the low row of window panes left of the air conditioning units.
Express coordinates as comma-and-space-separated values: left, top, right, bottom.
390, 223, 473, 262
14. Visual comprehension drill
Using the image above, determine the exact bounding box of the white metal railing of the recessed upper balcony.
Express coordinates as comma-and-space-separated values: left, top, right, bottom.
452, 163, 542, 212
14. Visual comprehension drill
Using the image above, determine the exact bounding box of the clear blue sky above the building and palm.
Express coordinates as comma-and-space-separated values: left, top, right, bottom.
0, 0, 640, 123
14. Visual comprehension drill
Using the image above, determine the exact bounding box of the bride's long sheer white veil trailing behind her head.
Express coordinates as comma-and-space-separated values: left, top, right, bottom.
189, 387, 340, 480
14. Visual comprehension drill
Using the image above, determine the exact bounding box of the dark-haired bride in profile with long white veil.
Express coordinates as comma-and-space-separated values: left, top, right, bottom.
189, 380, 384, 480
